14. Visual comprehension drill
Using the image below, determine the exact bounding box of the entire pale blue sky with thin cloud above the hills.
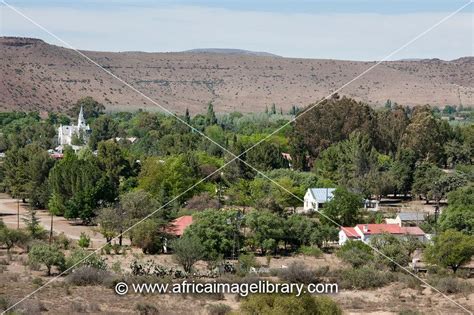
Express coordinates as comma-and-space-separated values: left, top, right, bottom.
0, 0, 474, 60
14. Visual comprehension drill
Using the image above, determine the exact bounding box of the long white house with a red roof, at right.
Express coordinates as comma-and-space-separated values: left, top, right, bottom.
339, 224, 427, 245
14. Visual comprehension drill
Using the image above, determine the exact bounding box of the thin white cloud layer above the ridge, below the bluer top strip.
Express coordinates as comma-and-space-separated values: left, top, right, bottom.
0, 7, 473, 60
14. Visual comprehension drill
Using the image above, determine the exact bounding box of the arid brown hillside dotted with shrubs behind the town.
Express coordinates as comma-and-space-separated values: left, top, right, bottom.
0, 37, 474, 113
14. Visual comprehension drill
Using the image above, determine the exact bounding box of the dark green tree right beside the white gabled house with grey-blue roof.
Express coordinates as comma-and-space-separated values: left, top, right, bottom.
320, 188, 362, 226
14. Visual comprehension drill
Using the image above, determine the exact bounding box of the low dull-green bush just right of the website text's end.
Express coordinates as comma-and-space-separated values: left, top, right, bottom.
339, 266, 392, 289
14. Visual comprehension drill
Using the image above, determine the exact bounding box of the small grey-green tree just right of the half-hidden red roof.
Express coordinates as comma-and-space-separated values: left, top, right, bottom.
171, 235, 204, 273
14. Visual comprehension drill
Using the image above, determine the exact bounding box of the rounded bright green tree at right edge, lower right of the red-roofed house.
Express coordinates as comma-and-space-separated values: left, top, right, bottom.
425, 230, 474, 273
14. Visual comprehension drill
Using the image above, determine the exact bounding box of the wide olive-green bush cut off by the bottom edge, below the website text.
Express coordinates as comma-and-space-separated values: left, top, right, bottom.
240, 294, 342, 315
